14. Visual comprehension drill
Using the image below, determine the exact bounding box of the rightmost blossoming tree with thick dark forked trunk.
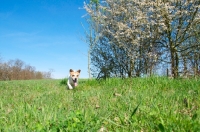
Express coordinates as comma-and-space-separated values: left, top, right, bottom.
153, 0, 200, 78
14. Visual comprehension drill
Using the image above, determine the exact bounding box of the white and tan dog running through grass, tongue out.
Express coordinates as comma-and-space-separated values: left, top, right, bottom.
67, 69, 81, 89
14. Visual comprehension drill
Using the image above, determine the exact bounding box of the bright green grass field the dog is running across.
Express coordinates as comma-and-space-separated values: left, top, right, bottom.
0, 77, 200, 132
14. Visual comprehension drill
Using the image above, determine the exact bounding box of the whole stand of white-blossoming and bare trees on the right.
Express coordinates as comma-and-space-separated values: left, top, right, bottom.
84, 0, 200, 78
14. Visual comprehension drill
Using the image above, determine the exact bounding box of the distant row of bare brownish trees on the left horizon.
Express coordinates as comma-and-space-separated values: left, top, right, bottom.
0, 56, 52, 81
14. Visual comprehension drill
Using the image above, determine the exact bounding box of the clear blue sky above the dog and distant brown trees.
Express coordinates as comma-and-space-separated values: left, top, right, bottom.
0, 0, 88, 78
